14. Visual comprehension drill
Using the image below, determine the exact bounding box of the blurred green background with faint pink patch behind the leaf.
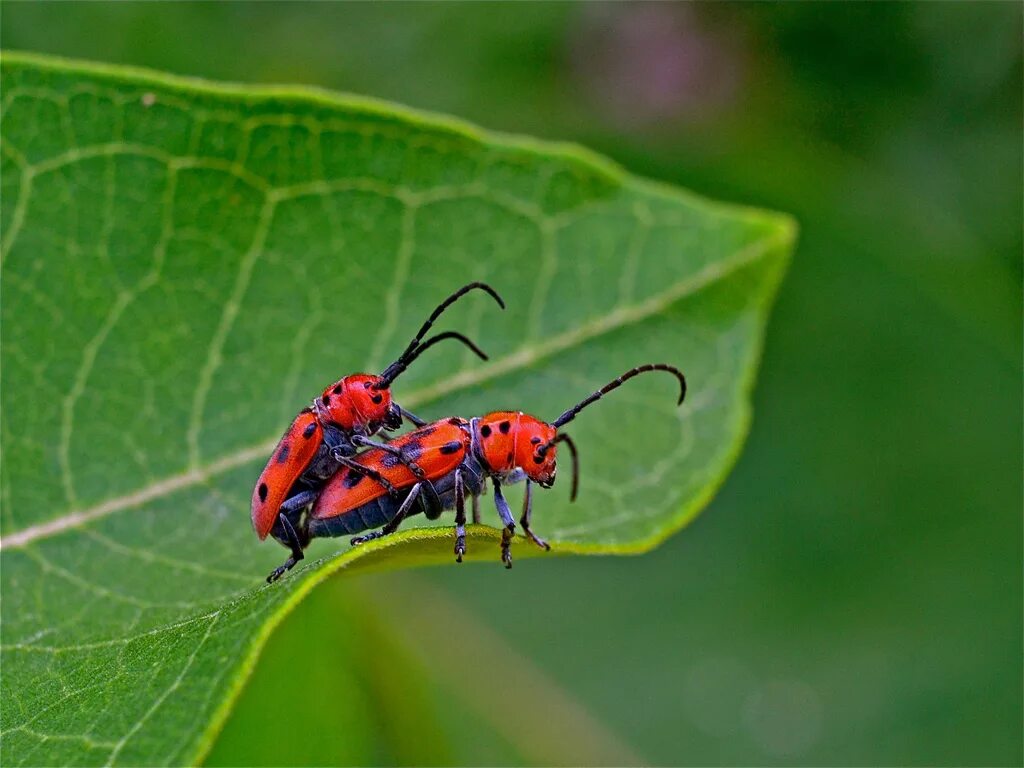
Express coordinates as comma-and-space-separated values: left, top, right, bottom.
6, 2, 1024, 765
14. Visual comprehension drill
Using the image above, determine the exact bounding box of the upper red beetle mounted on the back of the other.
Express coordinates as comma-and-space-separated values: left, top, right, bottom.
251, 283, 505, 557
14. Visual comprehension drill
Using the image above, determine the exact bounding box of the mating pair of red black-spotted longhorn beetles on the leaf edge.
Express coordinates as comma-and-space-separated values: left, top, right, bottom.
252, 283, 686, 582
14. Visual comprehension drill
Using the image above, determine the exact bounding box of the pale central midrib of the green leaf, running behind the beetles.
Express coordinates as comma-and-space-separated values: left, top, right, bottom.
0, 230, 793, 549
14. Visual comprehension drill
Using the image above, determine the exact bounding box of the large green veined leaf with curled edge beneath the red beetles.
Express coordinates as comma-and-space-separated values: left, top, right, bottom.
0, 54, 795, 765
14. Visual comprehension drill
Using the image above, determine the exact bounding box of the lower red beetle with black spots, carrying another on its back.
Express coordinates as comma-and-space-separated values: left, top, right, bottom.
267, 364, 686, 582
